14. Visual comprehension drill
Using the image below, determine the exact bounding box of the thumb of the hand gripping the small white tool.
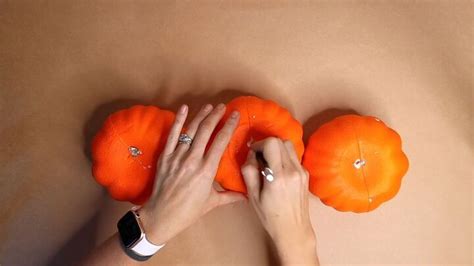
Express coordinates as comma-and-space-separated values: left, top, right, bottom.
240, 150, 262, 199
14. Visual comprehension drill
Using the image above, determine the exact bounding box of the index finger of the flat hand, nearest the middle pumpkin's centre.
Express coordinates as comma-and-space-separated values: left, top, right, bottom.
206, 111, 240, 169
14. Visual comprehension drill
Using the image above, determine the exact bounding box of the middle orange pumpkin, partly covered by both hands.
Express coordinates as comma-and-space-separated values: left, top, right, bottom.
211, 96, 304, 193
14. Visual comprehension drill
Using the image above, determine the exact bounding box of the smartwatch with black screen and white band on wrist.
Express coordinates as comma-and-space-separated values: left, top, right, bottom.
117, 207, 165, 257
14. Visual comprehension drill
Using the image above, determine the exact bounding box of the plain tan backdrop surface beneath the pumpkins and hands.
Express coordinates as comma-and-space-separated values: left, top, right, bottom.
0, 0, 474, 265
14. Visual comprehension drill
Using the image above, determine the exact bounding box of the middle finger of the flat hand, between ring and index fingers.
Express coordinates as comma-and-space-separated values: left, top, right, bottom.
190, 103, 225, 157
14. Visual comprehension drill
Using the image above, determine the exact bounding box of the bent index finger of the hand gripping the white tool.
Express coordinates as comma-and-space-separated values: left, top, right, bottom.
250, 137, 283, 172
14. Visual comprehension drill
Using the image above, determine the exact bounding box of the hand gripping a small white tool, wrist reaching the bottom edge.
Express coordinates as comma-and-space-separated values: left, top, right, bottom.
241, 137, 318, 265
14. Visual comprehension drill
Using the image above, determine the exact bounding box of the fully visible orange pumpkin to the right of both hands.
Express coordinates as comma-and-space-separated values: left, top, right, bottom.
303, 115, 408, 212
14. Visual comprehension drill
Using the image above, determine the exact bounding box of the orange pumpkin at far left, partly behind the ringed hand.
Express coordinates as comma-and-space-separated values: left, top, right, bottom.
92, 105, 174, 205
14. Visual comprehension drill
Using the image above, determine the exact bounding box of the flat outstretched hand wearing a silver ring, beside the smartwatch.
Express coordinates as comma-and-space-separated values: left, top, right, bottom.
139, 104, 245, 244
